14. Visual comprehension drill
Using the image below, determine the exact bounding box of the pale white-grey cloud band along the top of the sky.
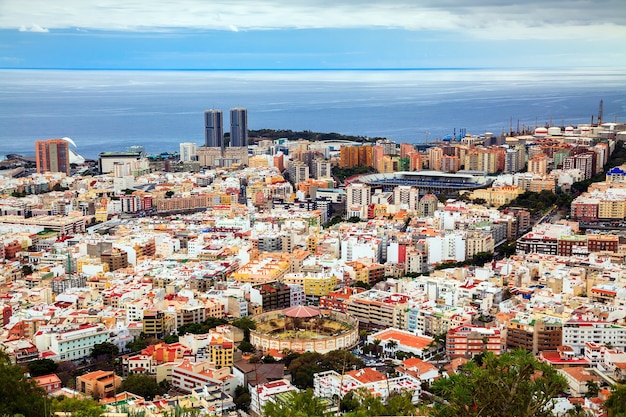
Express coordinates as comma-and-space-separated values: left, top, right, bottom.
0, 0, 626, 39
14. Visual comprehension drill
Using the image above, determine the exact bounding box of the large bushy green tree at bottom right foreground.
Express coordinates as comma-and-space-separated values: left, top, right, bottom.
432, 350, 567, 417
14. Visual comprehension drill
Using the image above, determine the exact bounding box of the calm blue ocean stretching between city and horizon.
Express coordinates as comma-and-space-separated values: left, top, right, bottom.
0, 69, 626, 159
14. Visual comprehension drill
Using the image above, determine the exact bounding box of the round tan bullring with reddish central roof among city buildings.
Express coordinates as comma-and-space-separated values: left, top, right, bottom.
250, 306, 359, 353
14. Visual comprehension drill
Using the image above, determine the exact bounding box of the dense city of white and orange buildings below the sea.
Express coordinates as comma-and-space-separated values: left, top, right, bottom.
0, 105, 626, 417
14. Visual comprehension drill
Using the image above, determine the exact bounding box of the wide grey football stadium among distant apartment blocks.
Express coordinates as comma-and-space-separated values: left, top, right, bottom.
352, 171, 493, 195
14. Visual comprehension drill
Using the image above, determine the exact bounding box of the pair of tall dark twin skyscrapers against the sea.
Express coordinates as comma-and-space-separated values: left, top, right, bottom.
204, 107, 248, 148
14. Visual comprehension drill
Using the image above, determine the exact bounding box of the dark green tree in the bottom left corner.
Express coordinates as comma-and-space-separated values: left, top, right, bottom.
0, 349, 46, 416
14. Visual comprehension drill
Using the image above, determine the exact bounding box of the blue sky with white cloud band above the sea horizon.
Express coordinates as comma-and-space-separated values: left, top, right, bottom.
0, 0, 626, 69
